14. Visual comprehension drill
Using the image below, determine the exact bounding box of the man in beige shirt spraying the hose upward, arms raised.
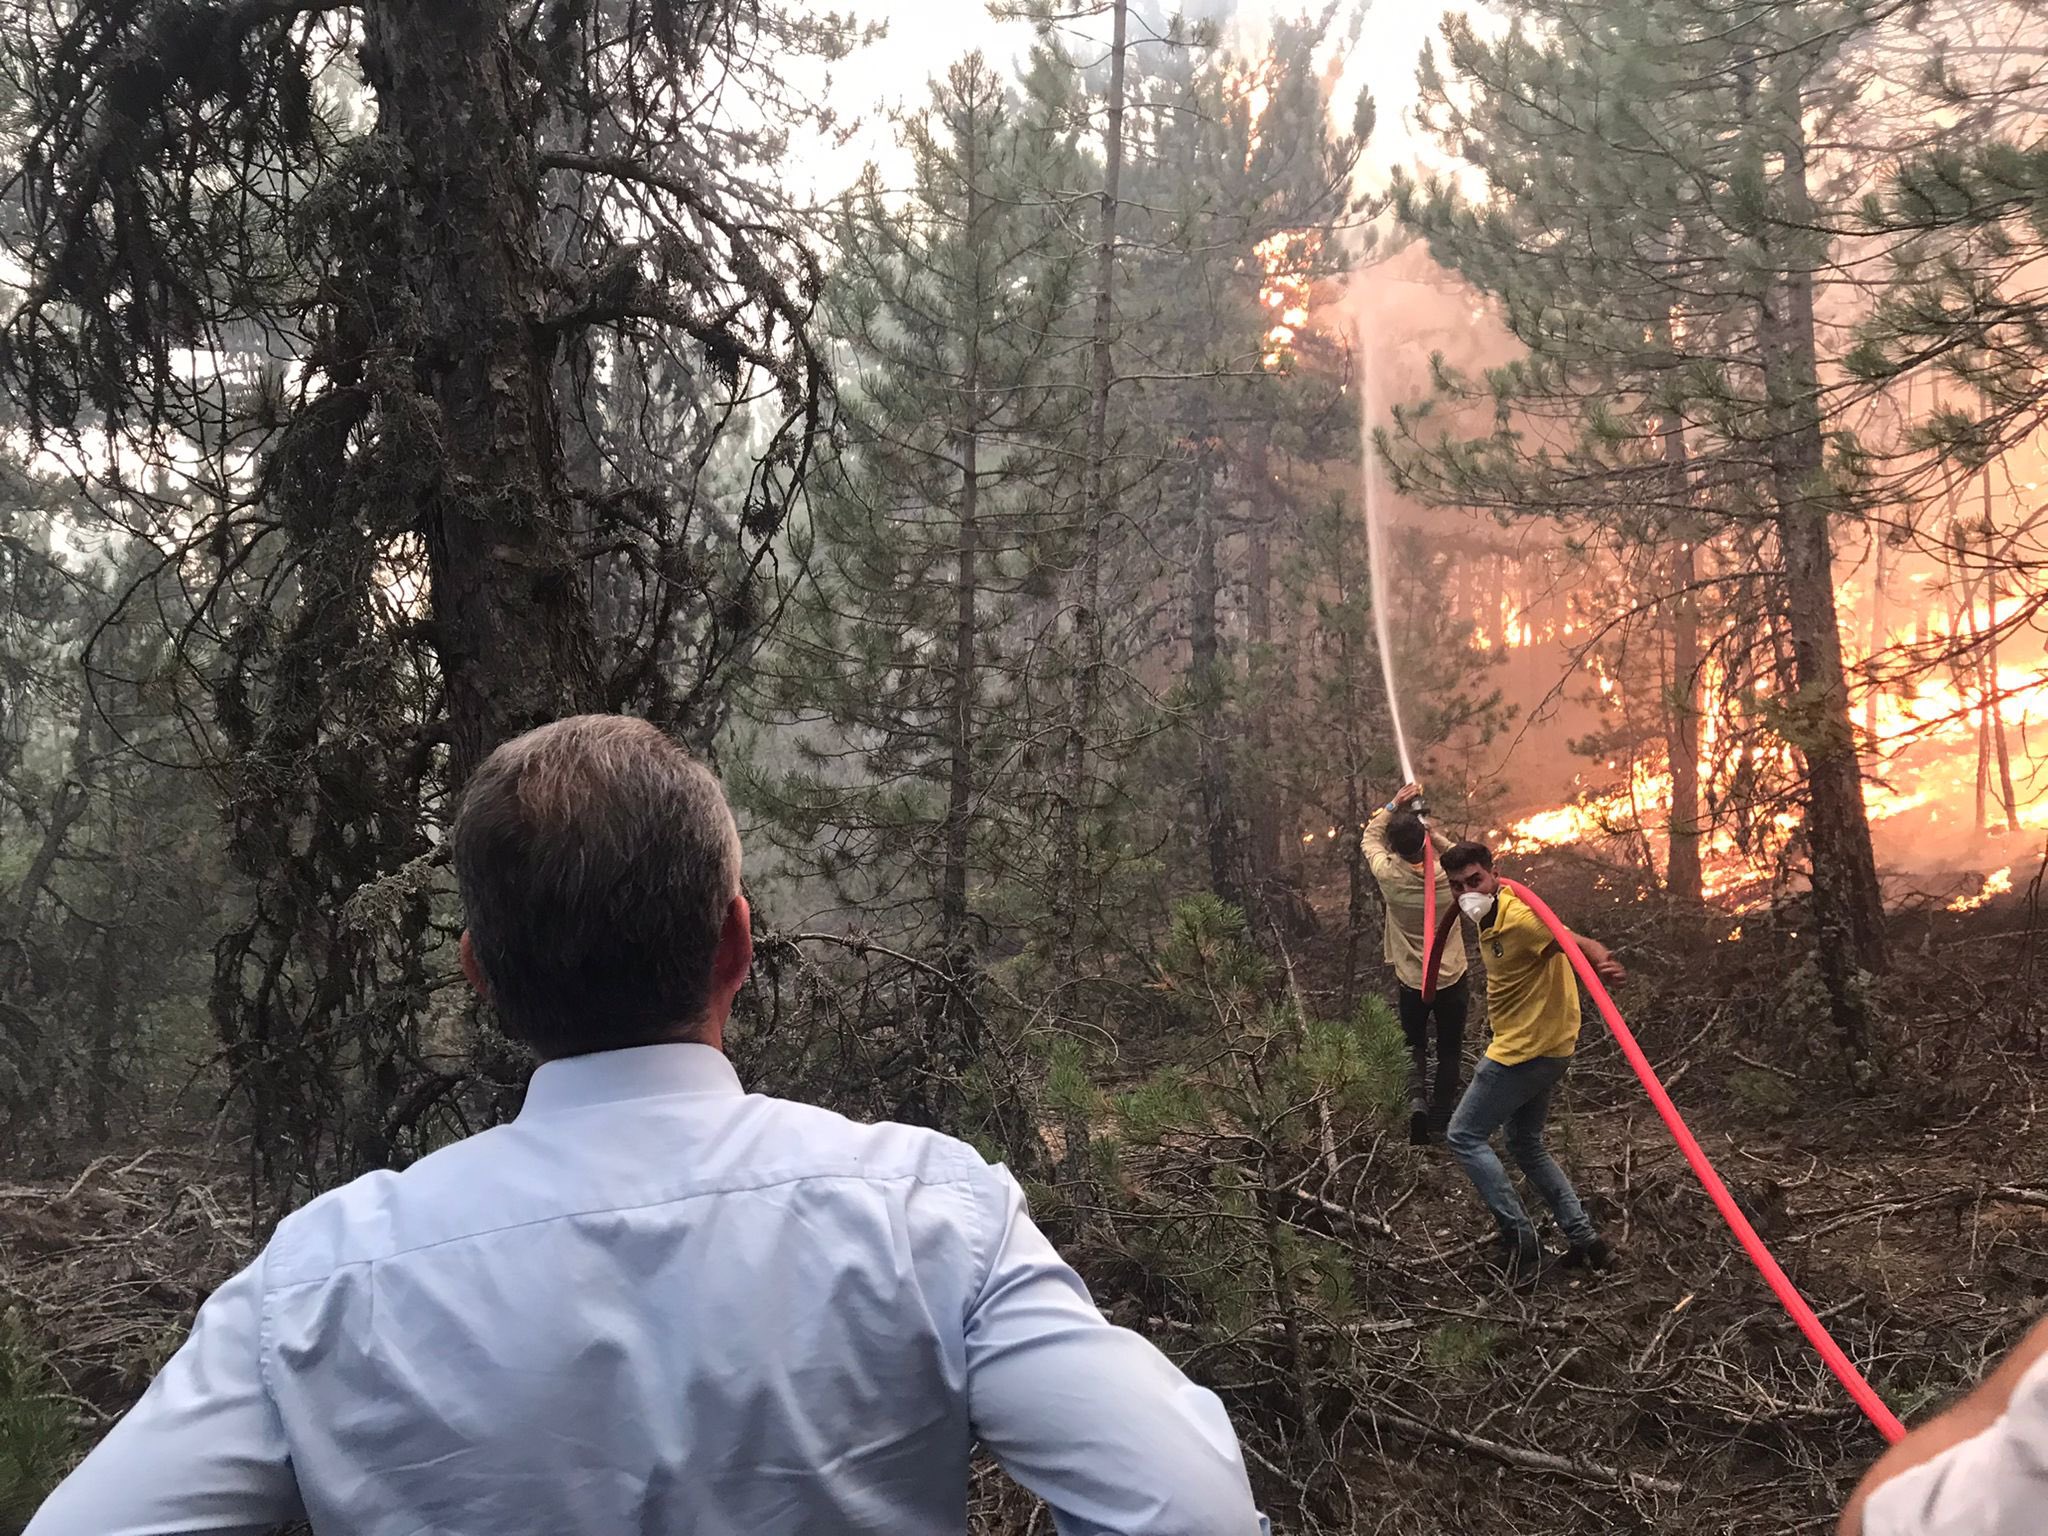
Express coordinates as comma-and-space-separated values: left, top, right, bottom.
1360, 784, 1466, 1147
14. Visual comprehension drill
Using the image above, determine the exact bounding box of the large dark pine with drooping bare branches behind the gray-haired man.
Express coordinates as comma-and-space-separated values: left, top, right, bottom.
0, 0, 848, 1192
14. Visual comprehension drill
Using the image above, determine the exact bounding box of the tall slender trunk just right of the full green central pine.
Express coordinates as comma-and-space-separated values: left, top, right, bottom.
1059, 0, 1130, 965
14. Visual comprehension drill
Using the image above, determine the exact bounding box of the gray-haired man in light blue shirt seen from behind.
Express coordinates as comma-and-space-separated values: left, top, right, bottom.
29, 717, 1264, 1536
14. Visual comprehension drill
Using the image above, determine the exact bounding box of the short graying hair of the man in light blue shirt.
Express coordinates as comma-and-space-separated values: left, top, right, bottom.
455, 715, 739, 1057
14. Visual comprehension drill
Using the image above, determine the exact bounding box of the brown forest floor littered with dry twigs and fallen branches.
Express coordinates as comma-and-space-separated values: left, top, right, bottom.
12, 860, 2048, 1536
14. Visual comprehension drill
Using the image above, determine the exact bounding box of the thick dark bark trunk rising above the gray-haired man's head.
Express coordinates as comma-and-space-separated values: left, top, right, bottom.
362, 0, 602, 784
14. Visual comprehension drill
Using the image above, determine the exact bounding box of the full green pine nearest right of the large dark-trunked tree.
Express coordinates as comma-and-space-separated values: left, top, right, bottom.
756, 55, 1085, 961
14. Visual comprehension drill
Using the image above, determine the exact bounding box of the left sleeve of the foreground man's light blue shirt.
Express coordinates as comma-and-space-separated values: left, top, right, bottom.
23, 1260, 303, 1536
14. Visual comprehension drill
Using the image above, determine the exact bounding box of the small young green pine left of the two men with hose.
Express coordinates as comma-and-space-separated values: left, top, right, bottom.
1102, 895, 1405, 1505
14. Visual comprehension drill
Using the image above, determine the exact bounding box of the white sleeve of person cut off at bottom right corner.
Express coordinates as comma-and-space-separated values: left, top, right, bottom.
1864, 1362, 2048, 1536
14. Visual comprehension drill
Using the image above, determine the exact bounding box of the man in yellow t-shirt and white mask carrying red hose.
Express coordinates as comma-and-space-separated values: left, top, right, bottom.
1442, 842, 1626, 1282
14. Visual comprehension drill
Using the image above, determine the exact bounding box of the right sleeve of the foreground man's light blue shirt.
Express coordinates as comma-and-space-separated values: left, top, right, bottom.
958, 1167, 1268, 1536
